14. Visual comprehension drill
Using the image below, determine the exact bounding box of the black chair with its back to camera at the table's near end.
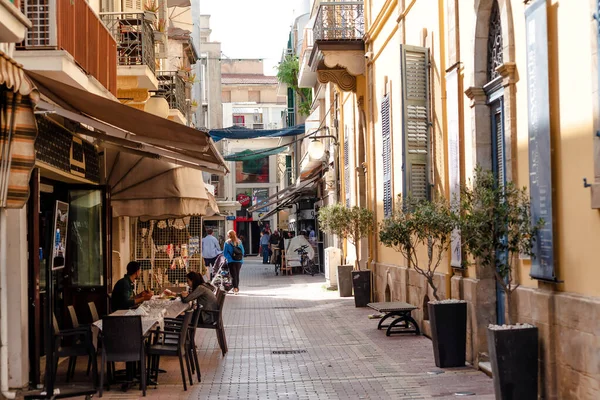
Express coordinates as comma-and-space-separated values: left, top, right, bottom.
99, 315, 146, 397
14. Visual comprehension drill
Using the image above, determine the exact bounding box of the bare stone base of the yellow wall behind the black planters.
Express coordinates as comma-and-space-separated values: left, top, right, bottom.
373, 263, 600, 400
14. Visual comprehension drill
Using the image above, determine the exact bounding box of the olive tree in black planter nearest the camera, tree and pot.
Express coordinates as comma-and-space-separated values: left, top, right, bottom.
460, 168, 544, 399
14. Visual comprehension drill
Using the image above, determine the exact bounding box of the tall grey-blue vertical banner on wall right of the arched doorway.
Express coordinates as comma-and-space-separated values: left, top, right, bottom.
525, 0, 556, 281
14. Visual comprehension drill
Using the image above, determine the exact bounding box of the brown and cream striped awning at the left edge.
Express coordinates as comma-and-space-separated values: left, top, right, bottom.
0, 51, 39, 208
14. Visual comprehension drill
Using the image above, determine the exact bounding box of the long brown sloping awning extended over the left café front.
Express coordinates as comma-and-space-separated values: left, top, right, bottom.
27, 71, 228, 174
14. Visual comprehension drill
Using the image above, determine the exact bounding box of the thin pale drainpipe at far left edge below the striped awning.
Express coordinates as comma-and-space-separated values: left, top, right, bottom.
0, 208, 16, 399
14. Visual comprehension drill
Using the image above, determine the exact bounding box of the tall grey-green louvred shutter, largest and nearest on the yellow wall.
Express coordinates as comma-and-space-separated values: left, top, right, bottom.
400, 45, 431, 200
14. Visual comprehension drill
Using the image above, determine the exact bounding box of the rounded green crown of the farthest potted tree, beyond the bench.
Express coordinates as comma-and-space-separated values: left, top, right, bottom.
318, 204, 375, 269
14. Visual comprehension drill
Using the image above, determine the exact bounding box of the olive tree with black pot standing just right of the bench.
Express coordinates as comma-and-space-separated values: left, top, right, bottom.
379, 195, 467, 368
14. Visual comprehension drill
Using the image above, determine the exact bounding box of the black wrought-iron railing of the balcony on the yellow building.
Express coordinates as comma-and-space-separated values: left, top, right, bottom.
313, 1, 365, 41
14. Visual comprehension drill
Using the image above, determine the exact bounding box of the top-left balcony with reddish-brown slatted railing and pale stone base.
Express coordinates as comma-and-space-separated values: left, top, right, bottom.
15, 0, 117, 97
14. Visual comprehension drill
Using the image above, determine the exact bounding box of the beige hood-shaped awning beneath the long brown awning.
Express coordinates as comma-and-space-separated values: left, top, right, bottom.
105, 150, 211, 219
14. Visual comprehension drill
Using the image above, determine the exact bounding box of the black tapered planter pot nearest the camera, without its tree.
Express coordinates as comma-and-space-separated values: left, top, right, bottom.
488, 327, 538, 400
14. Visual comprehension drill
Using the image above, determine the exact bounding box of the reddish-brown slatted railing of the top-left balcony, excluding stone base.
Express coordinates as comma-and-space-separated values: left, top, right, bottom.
15, 0, 117, 94
